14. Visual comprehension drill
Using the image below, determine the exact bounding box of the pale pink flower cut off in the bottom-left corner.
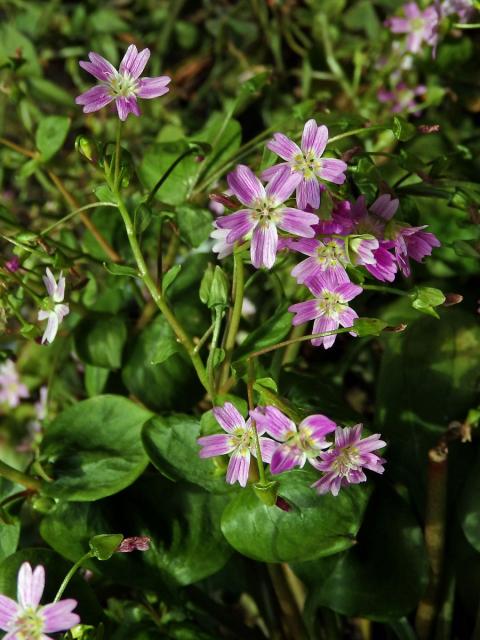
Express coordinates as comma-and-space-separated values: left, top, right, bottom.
0, 562, 80, 640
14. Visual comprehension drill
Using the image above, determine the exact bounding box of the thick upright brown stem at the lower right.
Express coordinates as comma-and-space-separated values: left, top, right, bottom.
415, 437, 448, 640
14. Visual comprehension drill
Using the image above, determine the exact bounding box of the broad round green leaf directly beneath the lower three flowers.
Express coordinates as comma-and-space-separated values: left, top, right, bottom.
222, 469, 369, 562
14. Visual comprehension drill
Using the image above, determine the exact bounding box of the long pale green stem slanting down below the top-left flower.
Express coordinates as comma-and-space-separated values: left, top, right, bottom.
115, 189, 213, 397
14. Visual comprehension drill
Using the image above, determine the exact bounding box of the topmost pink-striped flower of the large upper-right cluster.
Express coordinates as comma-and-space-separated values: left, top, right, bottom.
262, 120, 347, 209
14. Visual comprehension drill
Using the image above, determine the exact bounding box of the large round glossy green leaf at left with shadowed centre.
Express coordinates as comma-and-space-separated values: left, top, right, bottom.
41, 395, 151, 501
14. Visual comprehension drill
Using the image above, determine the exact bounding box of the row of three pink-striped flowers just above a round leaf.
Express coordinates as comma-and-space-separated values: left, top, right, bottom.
198, 402, 386, 495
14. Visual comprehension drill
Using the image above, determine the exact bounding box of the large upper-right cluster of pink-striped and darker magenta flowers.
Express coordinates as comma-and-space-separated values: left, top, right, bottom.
211, 120, 440, 349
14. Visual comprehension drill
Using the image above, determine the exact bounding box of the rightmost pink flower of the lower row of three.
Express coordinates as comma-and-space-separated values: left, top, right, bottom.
312, 424, 386, 496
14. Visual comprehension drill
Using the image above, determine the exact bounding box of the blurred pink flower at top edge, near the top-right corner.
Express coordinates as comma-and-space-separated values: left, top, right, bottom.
386, 2, 438, 53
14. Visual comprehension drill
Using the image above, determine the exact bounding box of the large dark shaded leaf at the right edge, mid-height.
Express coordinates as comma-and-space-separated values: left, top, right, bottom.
376, 308, 480, 505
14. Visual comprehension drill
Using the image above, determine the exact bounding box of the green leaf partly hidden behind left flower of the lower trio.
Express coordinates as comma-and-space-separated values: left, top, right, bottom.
142, 414, 229, 493
